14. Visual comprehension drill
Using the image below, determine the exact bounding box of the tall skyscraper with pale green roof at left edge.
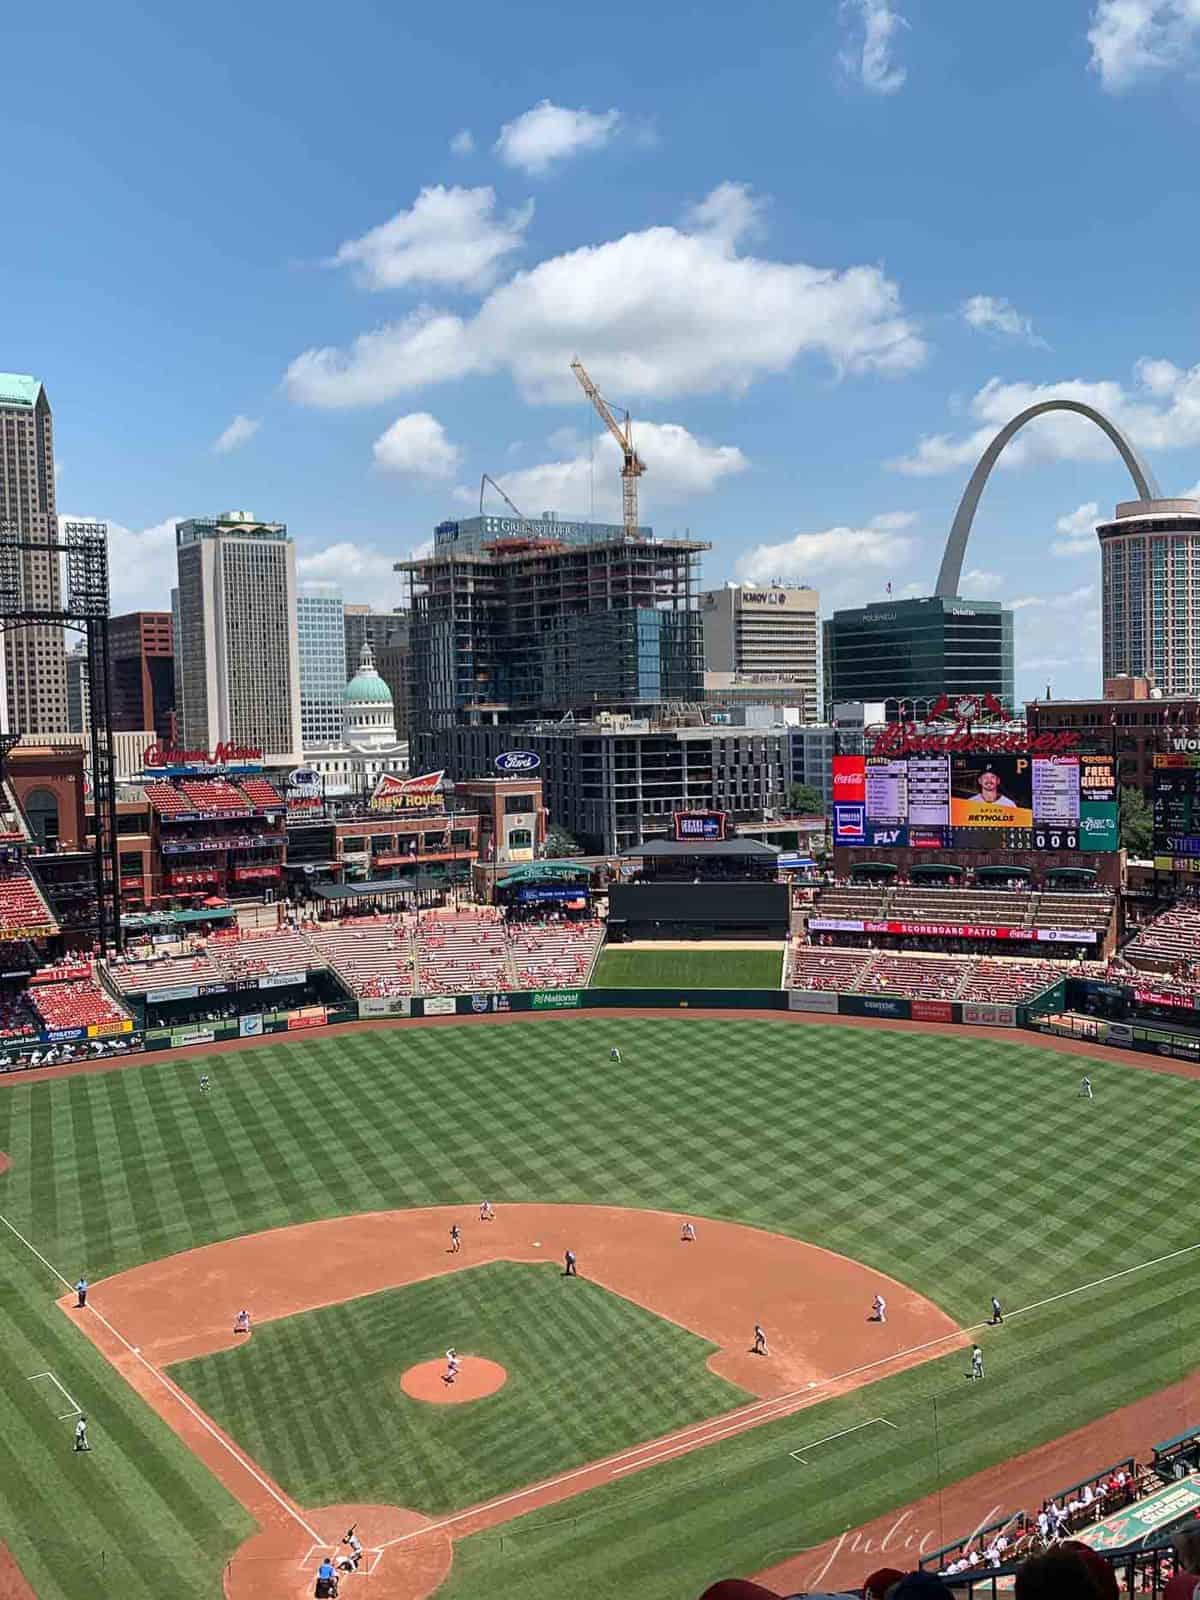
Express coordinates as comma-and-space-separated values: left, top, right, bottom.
0, 373, 69, 733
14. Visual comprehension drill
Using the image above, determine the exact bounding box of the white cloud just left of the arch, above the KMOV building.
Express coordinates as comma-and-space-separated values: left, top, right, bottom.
736, 512, 917, 611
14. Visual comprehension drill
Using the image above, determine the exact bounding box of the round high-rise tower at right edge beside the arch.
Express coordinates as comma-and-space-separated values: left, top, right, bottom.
1096, 499, 1200, 694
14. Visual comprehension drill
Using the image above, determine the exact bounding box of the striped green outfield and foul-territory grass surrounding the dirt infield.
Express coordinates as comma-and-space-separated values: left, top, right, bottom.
0, 1016, 1200, 1600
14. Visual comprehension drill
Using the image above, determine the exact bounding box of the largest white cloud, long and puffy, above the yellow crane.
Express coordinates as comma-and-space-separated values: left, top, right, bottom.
285, 192, 925, 406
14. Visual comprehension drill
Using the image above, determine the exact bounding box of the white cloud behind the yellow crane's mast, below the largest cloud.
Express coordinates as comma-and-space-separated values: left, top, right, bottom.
473, 422, 749, 523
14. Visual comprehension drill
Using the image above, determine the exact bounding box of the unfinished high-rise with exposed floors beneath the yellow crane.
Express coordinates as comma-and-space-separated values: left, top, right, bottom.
395, 515, 710, 766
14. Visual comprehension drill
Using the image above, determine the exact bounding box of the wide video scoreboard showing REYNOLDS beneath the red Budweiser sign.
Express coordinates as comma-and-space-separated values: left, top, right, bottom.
834, 750, 1120, 850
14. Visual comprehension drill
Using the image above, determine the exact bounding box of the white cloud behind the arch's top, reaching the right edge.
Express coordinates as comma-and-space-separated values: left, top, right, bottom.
890, 360, 1200, 477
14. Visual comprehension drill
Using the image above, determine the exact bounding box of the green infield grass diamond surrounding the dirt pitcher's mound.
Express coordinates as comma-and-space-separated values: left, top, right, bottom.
171, 1262, 750, 1514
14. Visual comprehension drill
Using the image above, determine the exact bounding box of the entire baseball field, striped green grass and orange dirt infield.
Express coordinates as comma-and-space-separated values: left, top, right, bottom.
0, 1014, 1200, 1600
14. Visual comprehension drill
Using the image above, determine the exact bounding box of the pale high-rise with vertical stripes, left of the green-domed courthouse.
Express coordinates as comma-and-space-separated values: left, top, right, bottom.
174, 510, 301, 765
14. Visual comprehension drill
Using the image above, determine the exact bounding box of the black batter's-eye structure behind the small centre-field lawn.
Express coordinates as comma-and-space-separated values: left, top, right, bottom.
608, 838, 792, 941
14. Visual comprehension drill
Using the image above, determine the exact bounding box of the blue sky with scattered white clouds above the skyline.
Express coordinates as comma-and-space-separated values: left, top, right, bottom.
0, 0, 1200, 694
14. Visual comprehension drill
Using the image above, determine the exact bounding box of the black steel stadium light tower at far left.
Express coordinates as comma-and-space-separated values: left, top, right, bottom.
0, 522, 123, 950
